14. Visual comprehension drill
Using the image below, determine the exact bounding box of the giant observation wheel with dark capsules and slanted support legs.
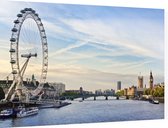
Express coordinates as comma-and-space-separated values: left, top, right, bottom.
6, 8, 48, 99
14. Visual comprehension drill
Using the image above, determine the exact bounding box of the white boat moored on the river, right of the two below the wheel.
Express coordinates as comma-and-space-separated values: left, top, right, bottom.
16, 107, 39, 118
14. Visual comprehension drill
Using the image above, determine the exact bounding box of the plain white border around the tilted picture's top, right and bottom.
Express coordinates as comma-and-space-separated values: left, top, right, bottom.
11, 0, 168, 128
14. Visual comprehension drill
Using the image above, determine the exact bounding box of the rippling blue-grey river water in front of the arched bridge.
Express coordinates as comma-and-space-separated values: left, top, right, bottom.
0, 97, 164, 128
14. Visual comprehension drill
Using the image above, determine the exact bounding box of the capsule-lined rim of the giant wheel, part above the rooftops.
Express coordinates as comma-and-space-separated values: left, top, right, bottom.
9, 8, 48, 83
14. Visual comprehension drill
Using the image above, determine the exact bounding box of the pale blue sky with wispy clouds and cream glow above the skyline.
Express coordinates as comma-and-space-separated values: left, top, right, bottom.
0, 2, 164, 91
